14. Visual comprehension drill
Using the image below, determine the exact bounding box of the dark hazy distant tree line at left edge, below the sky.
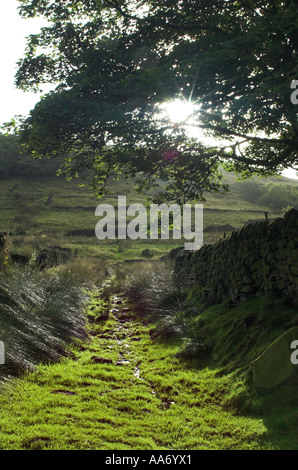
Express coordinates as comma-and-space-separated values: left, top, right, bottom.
0, 134, 60, 179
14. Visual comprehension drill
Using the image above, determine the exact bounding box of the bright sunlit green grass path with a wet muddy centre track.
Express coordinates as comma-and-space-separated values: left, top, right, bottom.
0, 295, 269, 450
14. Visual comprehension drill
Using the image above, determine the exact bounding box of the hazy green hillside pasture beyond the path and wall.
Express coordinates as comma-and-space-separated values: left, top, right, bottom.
0, 163, 298, 259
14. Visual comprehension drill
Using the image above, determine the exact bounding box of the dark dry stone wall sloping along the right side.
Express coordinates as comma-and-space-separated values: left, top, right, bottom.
170, 209, 298, 305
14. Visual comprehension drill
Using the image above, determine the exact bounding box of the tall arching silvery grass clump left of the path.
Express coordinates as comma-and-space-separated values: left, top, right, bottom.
0, 261, 106, 378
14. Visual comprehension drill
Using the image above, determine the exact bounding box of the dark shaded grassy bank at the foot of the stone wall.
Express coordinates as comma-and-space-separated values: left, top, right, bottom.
186, 295, 297, 370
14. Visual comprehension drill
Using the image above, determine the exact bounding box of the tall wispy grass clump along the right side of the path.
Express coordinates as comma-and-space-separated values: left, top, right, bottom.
113, 260, 205, 356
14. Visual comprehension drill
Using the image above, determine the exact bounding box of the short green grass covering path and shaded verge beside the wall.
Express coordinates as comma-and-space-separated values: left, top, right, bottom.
0, 272, 298, 451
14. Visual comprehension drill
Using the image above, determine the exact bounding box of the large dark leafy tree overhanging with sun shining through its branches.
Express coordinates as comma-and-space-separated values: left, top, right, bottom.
11, 0, 298, 202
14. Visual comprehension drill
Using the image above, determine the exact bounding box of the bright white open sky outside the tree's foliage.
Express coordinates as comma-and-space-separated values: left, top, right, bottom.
0, 0, 297, 178
